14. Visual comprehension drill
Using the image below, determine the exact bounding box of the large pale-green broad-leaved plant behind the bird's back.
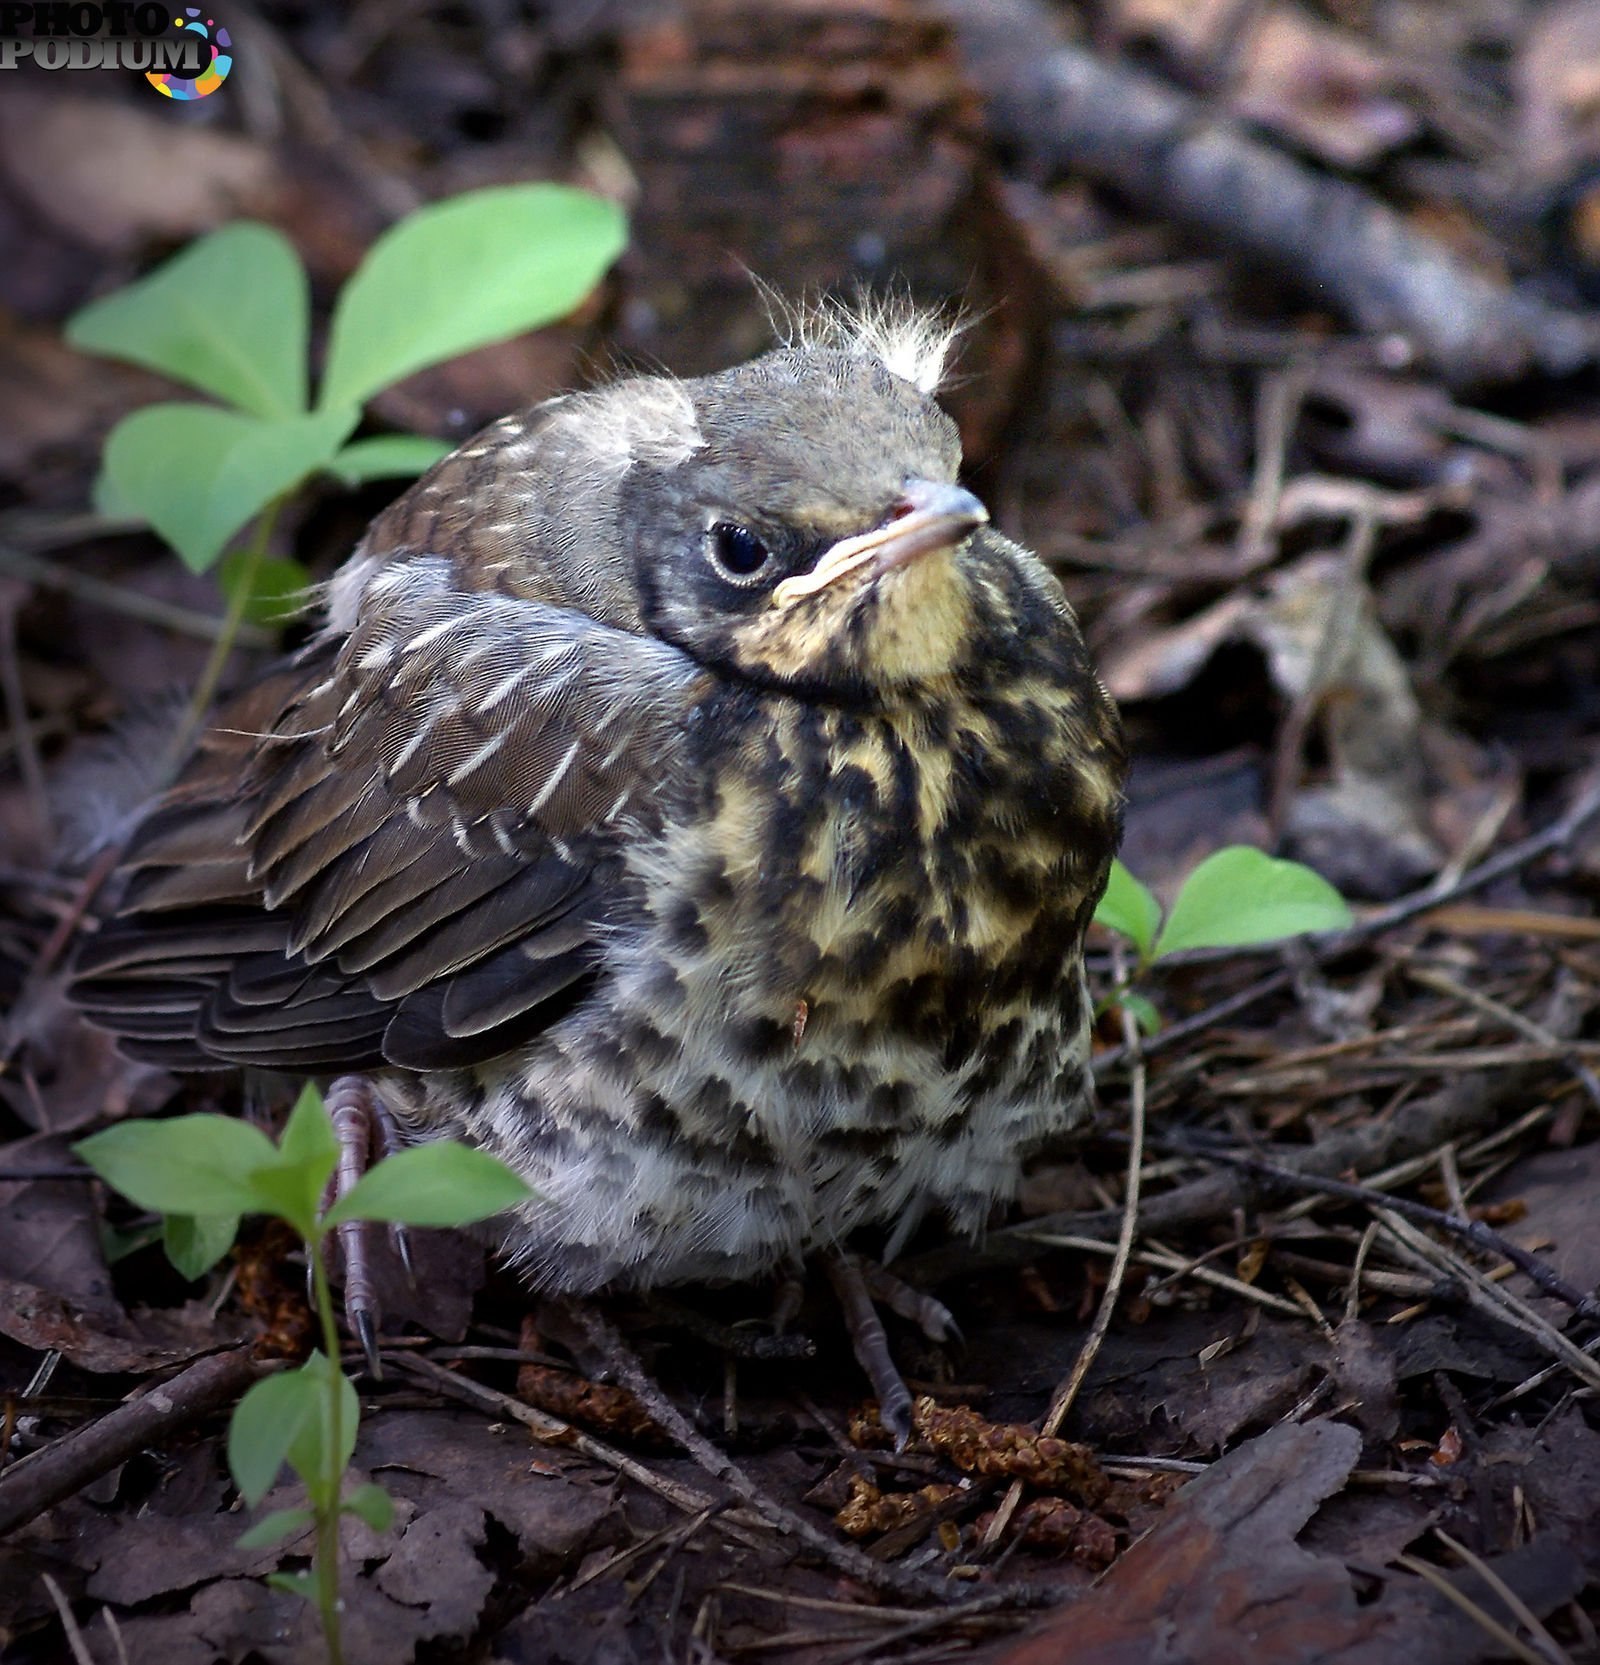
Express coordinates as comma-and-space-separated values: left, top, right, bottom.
67, 185, 626, 596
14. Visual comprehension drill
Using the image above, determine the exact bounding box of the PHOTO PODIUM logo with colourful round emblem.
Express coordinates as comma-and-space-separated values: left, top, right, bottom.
0, 0, 233, 100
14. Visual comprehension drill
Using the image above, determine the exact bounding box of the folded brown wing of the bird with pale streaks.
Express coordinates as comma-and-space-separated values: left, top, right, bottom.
73, 558, 704, 1071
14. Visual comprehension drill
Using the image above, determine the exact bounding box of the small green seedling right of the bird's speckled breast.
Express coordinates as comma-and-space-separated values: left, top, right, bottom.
1094, 844, 1350, 1034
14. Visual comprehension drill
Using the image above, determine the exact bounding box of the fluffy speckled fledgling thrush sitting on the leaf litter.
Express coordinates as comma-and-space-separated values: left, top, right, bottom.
75, 311, 1124, 1420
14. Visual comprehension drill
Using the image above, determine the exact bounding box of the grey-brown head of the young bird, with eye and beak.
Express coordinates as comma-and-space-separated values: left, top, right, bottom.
619, 313, 989, 696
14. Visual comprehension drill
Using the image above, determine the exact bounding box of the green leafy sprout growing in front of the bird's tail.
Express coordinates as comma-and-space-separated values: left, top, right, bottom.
73, 1087, 531, 1665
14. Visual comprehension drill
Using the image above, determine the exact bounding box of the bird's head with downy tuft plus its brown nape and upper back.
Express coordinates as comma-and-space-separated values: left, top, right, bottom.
344, 310, 1064, 701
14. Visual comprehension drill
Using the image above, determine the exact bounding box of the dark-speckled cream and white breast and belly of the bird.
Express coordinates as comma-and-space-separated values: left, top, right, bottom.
412, 682, 1114, 1289
